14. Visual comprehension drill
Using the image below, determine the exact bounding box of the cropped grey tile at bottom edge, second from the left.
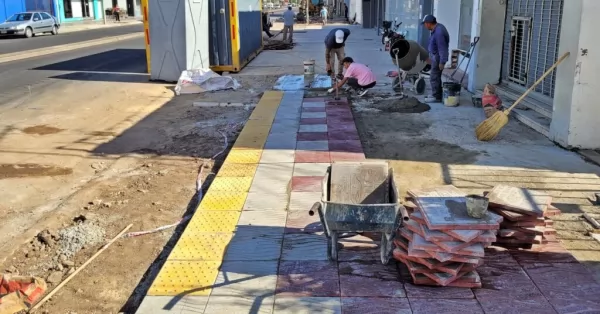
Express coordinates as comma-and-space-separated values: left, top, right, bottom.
204, 296, 275, 314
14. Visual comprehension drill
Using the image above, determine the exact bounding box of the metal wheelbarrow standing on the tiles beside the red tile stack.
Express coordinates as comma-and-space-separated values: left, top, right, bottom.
309, 162, 408, 265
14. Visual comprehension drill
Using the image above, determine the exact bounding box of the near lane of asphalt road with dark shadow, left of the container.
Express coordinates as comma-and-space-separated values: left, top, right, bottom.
0, 38, 148, 114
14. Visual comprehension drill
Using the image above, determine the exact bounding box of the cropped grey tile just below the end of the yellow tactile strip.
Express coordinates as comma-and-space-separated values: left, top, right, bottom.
135, 296, 208, 314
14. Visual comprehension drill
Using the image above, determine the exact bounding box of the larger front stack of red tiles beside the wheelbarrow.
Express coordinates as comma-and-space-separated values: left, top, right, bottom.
394, 185, 502, 288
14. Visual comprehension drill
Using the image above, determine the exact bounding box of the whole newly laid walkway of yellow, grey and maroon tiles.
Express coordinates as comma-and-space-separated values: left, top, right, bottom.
137, 91, 600, 314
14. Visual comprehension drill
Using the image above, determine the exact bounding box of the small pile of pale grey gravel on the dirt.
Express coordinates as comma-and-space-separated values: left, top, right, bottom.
58, 223, 105, 258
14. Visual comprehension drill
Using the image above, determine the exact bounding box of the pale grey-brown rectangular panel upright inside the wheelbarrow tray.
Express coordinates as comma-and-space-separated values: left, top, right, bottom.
330, 162, 390, 204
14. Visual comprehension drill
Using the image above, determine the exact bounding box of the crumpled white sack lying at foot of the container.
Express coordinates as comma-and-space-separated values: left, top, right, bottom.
175, 69, 241, 95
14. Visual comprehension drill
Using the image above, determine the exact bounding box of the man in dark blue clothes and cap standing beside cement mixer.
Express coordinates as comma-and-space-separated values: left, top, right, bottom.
421, 15, 450, 103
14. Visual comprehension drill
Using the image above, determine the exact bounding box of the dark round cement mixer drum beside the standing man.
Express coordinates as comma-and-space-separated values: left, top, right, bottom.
390, 39, 429, 74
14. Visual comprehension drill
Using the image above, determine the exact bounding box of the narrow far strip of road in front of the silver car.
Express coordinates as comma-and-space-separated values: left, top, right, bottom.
0, 24, 144, 54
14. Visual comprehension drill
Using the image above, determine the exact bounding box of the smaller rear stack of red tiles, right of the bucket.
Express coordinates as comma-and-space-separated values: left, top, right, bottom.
487, 185, 560, 249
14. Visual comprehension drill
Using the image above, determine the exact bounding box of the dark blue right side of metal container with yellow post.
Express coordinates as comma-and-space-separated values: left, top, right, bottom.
207, 0, 263, 72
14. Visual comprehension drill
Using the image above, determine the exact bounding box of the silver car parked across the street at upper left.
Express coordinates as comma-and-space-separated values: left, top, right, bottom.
0, 11, 60, 38
